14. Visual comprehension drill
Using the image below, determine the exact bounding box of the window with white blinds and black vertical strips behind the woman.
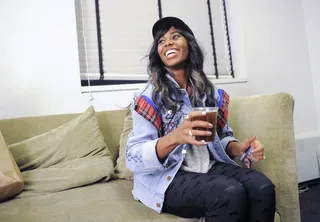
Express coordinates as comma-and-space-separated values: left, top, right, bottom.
75, 0, 234, 86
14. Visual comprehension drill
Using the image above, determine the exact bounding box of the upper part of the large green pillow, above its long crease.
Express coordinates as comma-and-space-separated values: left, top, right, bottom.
8, 107, 110, 171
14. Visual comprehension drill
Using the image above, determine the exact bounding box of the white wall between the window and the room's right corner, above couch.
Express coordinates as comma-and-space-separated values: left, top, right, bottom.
225, 0, 320, 134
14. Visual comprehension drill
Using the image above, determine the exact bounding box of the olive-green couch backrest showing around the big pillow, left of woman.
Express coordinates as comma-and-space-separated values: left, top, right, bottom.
0, 110, 125, 165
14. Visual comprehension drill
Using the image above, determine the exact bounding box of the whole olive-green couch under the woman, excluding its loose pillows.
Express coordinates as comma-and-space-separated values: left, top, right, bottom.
0, 93, 300, 222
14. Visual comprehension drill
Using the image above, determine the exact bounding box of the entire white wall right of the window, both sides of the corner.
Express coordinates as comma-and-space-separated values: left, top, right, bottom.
225, 0, 320, 182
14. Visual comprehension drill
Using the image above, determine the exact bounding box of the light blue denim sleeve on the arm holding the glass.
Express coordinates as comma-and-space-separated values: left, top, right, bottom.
126, 102, 164, 173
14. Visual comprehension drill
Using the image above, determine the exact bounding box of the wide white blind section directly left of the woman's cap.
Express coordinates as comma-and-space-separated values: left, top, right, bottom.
99, 0, 158, 80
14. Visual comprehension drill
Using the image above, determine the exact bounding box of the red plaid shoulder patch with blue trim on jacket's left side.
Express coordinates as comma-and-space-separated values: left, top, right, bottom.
135, 96, 163, 137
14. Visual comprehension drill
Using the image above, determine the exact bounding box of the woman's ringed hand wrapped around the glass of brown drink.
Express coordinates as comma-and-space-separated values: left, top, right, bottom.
168, 111, 214, 146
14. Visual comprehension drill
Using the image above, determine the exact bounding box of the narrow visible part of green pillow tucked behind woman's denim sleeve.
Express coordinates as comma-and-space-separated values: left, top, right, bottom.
114, 108, 133, 180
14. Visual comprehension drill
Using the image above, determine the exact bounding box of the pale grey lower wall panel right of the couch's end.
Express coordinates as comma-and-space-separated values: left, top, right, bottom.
295, 131, 320, 183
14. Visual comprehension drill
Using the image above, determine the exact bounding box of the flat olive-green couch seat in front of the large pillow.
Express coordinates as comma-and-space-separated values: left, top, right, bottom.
0, 180, 197, 222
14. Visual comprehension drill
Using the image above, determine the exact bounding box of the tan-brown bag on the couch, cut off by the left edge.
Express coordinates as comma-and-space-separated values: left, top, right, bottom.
0, 132, 24, 202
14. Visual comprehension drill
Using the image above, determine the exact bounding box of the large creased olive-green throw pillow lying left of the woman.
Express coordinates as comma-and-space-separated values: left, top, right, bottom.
9, 106, 114, 193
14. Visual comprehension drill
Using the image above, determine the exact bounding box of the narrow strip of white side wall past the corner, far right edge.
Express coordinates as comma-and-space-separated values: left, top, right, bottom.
297, 0, 320, 181
